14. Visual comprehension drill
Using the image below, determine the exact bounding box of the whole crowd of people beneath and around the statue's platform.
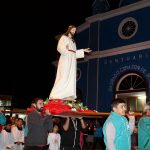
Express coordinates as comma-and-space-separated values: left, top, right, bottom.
0, 98, 150, 150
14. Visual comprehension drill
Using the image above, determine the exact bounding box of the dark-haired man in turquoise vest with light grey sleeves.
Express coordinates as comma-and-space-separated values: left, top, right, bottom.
103, 98, 135, 150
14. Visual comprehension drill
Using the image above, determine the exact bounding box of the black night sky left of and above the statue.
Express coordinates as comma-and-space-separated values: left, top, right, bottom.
0, 0, 94, 108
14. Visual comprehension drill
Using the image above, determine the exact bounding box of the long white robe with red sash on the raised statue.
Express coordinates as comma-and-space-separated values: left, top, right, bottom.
49, 35, 84, 99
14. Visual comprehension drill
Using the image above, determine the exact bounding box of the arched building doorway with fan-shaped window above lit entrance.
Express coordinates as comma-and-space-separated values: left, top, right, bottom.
115, 72, 147, 112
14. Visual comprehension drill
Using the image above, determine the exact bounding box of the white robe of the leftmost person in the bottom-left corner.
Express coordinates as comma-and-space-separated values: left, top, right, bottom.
0, 130, 14, 150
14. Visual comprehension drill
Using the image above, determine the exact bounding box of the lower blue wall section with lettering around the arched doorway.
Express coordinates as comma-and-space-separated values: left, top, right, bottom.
98, 49, 150, 111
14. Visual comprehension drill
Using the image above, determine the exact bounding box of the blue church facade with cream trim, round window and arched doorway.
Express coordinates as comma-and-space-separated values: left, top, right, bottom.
77, 0, 150, 112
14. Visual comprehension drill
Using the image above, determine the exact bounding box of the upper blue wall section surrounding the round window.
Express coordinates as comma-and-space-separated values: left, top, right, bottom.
98, 7, 150, 50
